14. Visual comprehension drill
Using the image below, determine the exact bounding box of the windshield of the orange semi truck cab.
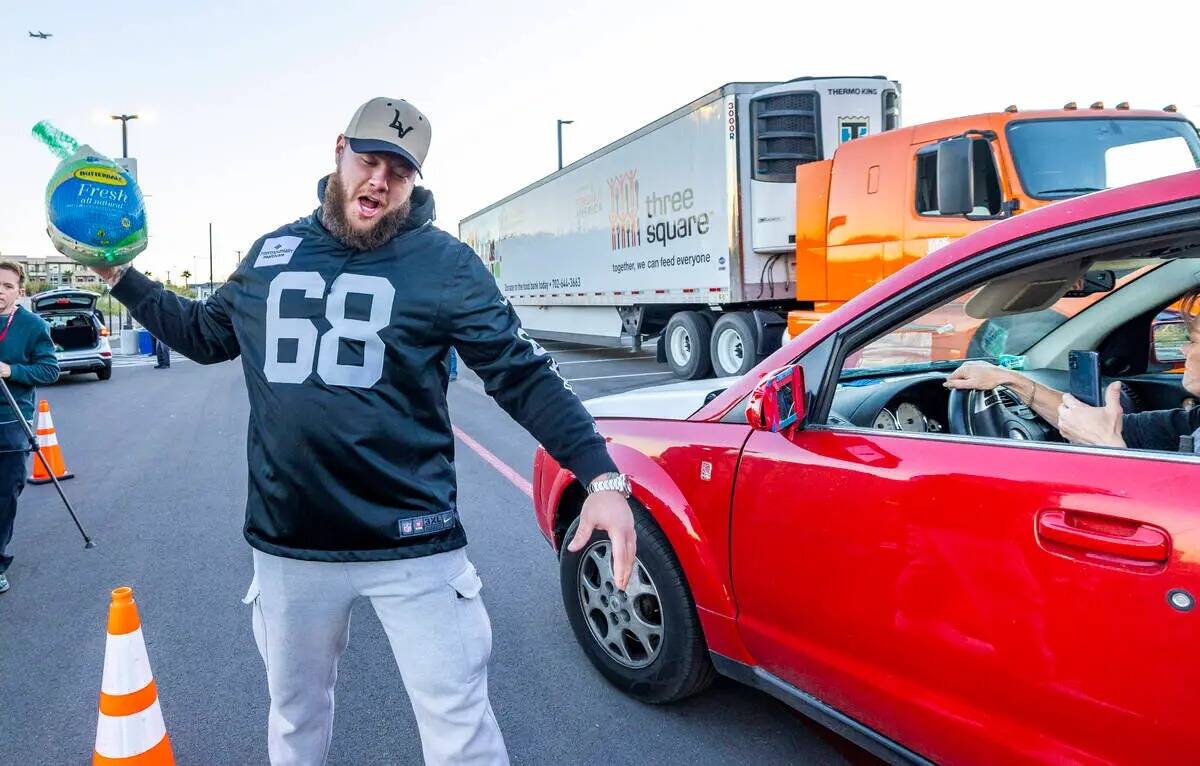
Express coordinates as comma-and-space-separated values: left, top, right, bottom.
1008, 118, 1200, 199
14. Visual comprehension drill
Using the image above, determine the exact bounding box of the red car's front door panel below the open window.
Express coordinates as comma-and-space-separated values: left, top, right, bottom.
732, 427, 1200, 764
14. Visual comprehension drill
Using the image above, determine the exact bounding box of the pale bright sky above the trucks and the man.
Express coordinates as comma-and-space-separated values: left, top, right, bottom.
0, 0, 1200, 282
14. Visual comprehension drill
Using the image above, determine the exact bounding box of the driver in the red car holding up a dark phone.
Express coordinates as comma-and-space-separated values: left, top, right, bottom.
946, 288, 1200, 451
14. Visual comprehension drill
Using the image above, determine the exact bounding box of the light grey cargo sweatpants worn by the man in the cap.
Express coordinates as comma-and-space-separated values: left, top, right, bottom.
245, 549, 509, 766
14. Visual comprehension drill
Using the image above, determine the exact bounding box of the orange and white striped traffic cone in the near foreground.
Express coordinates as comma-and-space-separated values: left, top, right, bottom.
91, 588, 175, 766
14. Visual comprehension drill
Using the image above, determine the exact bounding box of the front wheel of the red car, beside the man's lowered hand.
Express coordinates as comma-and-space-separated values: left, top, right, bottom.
559, 503, 716, 704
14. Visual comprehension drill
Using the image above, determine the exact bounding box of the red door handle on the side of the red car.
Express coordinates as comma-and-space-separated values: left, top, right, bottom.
1038, 510, 1170, 563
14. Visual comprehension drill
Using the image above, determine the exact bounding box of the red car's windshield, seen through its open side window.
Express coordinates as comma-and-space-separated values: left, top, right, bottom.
841, 258, 1163, 379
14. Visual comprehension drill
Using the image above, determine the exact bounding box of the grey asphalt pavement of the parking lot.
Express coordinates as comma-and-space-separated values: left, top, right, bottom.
0, 345, 870, 765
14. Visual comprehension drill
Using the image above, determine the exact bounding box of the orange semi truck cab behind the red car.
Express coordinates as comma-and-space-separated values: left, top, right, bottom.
784, 103, 1200, 342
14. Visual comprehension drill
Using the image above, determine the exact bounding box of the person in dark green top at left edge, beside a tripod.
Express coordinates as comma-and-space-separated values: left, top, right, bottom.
0, 261, 59, 593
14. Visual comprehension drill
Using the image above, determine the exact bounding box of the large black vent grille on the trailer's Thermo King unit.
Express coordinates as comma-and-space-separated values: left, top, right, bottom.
750, 92, 821, 182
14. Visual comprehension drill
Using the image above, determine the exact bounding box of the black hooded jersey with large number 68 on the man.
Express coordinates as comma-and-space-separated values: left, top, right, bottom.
113, 184, 616, 561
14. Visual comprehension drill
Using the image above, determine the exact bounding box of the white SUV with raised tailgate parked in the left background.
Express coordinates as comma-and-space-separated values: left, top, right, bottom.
29, 287, 113, 381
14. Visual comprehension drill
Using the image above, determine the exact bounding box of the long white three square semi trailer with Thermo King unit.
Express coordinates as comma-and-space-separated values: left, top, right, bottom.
458, 77, 900, 378
